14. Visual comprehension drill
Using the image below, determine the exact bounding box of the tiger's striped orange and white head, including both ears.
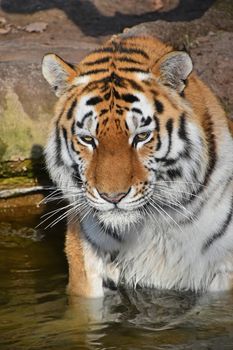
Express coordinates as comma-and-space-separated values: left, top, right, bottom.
42, 38, 204, 231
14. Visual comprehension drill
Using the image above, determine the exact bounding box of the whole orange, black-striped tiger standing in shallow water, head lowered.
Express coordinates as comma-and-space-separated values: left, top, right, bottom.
42, 33, 233, 297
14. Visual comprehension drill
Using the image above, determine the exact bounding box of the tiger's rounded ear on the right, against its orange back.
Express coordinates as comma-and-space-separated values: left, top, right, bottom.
152, 51, 193, 93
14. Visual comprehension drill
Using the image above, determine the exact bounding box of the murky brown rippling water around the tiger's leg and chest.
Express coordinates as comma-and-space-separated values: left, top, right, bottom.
0, 209, 233, 350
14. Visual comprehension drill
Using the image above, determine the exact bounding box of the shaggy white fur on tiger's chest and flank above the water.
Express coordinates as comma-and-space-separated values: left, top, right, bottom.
114, 176, 233, 290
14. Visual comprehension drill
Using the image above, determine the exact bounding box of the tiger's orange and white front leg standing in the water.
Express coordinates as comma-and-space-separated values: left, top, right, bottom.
65, 223, 104, 298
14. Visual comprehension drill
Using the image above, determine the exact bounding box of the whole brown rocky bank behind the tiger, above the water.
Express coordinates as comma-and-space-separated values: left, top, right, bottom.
0, 0, 233, 193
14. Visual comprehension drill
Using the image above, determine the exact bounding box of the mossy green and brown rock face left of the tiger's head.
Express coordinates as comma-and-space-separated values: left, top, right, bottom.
0, 38, 97, 161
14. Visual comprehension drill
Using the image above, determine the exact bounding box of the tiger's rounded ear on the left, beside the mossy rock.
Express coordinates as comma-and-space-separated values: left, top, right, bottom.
42, 54, 78, 97
